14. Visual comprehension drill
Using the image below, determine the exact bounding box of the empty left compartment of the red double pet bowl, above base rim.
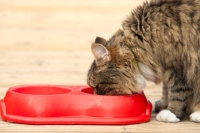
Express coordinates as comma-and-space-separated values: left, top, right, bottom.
4, 85, 72, 117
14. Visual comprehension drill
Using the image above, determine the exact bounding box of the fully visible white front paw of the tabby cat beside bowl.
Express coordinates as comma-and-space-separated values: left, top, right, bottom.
156, 109, 180, 122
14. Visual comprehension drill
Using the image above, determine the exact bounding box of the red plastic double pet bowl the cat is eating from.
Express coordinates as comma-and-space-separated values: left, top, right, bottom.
0, 85, 152, 125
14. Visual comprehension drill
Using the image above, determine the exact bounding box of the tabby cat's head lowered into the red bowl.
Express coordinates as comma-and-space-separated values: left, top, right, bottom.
87, 30, 145, 95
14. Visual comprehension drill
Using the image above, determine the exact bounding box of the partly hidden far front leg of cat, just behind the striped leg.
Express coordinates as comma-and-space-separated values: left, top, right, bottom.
152, 83, 168, 112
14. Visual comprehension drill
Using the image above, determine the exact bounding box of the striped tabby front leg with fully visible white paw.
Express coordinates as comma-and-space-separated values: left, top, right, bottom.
156, 70, 193, 122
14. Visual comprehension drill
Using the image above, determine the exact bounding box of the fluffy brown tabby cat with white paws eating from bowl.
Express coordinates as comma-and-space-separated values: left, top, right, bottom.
87, 0, 200, 122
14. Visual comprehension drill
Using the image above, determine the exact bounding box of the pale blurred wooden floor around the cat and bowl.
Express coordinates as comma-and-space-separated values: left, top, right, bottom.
0, 0, 200, 133
